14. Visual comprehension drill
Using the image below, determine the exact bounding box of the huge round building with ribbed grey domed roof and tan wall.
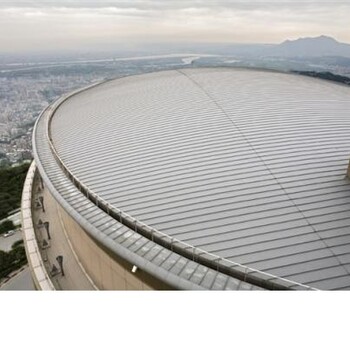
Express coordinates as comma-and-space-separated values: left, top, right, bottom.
22, 68, 350, 290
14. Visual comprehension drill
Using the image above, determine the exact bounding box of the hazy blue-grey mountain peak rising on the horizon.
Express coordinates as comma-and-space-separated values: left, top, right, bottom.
263, 35, 350, 57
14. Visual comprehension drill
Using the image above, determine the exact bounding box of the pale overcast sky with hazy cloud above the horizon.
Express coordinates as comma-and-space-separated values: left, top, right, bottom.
0, 0, 350, 52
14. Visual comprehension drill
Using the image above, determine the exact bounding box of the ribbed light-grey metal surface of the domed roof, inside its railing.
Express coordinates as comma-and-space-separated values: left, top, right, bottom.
34, 68, 350, 289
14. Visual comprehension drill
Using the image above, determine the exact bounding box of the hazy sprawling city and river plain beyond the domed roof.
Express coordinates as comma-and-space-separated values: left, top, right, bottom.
0, 39, 350, 166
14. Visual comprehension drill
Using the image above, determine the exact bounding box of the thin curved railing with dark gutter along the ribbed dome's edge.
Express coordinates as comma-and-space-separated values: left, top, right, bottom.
39, 78, 317, 290
